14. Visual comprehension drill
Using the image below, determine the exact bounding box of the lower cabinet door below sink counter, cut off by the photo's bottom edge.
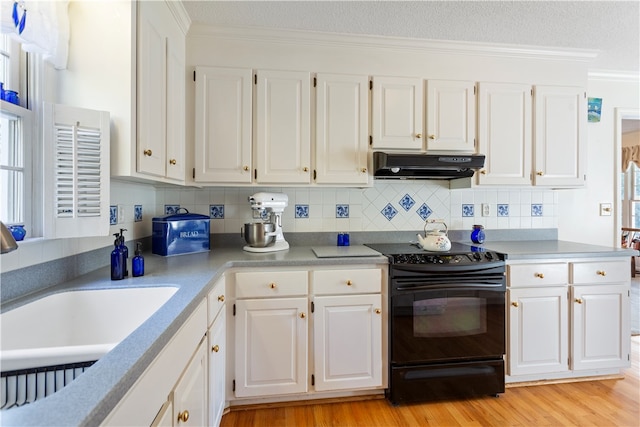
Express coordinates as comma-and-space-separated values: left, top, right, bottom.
173, 340, 208, 426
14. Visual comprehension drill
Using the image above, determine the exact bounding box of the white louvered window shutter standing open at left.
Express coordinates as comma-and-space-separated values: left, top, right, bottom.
43, 103, 110, 238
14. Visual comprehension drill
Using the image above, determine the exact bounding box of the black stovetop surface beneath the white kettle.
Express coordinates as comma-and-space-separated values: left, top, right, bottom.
365, 242, 504, 265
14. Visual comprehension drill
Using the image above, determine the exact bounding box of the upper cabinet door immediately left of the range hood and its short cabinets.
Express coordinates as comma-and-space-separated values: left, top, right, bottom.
316, 73, 369, 184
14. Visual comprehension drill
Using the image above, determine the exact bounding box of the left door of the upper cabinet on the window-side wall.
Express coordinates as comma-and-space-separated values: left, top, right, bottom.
137, 2, 166, 177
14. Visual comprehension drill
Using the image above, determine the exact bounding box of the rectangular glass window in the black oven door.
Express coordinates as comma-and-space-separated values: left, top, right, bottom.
413, 297, 487, 338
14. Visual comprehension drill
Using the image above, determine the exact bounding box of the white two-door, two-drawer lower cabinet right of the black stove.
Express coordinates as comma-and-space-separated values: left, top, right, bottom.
506, 258, 630, 382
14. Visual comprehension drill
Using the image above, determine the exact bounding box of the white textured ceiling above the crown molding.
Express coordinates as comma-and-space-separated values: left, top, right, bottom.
183, 0, 640, 72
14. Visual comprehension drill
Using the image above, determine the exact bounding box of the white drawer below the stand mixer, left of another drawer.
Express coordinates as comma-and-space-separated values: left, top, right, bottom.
236, 270, 309, 298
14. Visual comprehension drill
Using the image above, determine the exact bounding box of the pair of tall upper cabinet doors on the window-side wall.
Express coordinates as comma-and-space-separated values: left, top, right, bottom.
137, 2, 185, 181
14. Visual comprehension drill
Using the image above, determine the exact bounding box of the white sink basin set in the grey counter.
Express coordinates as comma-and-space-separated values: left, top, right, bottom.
0, 286, 178, 372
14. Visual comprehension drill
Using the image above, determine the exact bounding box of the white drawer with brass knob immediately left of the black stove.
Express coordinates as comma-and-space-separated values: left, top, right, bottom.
312, 268, 382, 295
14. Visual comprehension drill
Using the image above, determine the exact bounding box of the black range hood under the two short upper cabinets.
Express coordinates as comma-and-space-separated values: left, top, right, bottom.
373, 151, 485, 180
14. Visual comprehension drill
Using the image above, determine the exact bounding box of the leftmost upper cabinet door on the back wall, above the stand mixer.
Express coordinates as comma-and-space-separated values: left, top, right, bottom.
194, 67, 252, 184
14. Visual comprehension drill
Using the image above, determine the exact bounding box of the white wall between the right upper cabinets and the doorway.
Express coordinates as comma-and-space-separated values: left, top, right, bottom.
558, 76, 640, 247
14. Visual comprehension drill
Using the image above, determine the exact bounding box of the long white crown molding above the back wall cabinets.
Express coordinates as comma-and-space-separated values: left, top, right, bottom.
187, 22, 599, 62
